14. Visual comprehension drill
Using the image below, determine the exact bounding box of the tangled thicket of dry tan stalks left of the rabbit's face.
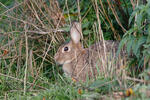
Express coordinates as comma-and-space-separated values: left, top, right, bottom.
0, 0, 65, 95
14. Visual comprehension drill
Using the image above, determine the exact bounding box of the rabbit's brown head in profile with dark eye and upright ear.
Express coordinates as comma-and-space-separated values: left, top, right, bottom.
54, 22, 84, 65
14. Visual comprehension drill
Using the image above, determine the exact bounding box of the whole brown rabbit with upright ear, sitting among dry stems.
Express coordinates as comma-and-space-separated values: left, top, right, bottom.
54, 22, 125, 81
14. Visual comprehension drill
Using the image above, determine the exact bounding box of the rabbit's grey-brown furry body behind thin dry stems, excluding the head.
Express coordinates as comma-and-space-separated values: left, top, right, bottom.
73, 40, 122, 80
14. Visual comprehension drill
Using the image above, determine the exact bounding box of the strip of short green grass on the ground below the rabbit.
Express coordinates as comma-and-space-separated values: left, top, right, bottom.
0, 70, 150, 100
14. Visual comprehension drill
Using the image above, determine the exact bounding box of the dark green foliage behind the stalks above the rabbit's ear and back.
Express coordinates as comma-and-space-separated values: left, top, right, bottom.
58, 0, 132, 41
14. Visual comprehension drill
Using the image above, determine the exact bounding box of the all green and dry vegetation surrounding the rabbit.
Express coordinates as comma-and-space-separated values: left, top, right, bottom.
0, 0, 150, 100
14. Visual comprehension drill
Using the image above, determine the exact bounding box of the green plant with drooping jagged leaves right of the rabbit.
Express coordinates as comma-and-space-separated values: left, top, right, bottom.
120, 1, 150, 67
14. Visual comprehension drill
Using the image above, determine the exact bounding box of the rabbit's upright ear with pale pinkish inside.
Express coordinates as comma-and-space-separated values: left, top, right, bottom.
70, 22, 81, 44
